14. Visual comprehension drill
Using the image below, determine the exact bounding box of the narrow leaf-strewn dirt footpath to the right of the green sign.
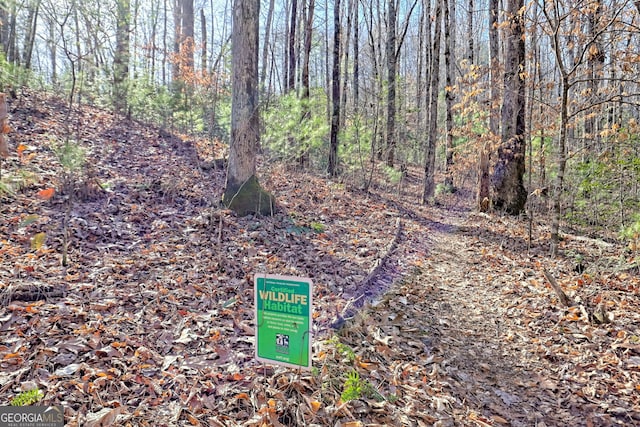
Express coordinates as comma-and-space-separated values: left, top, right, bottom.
416, 212, 566, 426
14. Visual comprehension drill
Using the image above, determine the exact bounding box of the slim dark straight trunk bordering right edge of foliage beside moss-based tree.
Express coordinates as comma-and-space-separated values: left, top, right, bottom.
327, 0, 341, 176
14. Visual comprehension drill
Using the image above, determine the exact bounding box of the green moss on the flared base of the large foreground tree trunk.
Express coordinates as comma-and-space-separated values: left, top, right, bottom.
222, 175, 275, 216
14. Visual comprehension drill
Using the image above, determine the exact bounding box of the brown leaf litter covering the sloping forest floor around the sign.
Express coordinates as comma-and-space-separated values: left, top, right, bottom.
0, 94, 640, 426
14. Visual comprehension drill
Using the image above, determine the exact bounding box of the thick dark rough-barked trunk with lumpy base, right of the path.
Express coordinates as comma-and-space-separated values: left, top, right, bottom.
491, 0, 527, 215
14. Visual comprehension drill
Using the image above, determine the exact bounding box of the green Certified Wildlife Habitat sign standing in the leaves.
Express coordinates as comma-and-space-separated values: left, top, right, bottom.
254, 274, 313, 369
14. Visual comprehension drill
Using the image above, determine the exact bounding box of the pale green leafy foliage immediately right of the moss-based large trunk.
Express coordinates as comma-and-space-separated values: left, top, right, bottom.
262, 92, 329, 166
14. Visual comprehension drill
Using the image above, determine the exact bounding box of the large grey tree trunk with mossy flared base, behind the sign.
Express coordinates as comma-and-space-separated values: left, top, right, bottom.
222, 0, 274, 216
